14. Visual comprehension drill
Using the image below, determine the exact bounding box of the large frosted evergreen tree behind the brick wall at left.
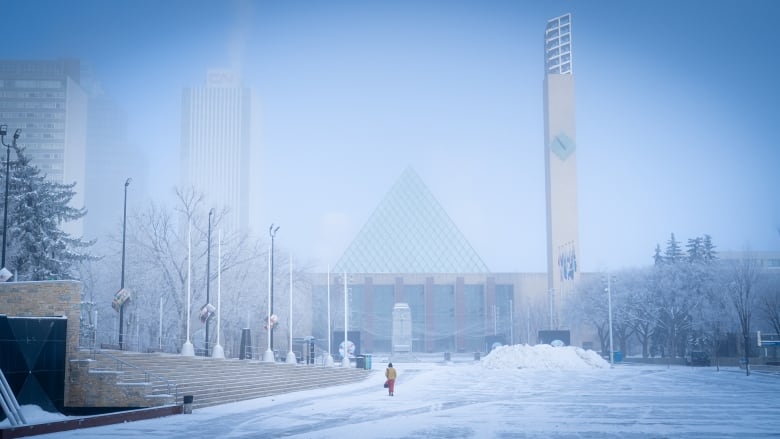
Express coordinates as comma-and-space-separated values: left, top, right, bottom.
2, 148, 94, 280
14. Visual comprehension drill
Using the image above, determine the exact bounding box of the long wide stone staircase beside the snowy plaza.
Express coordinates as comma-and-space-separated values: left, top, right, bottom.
79, 350, 370, 408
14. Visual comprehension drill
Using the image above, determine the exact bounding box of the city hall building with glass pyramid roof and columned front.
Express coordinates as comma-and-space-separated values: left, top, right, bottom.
312, 168, 547, 354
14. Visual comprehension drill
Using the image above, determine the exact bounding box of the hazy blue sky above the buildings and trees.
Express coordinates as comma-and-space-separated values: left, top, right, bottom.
0, 0, 780, 271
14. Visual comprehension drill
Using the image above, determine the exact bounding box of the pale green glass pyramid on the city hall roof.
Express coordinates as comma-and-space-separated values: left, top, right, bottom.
333, 168, 488, 273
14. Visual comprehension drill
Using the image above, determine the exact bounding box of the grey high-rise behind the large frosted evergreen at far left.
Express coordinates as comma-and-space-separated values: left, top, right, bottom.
0, 59, 87, 236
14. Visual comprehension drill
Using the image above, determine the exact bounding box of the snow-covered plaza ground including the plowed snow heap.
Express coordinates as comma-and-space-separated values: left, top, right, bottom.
10, 345, 780, 439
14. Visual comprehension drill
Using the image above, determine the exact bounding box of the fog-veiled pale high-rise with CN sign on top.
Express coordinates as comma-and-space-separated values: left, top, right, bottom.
181, 70, 252, 233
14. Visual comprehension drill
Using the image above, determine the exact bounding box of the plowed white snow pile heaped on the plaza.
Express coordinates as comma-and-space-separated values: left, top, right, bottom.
480, 344, 609, 369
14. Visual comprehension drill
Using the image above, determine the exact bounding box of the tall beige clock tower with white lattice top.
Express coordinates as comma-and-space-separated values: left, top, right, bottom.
544, 14, 579, 327
